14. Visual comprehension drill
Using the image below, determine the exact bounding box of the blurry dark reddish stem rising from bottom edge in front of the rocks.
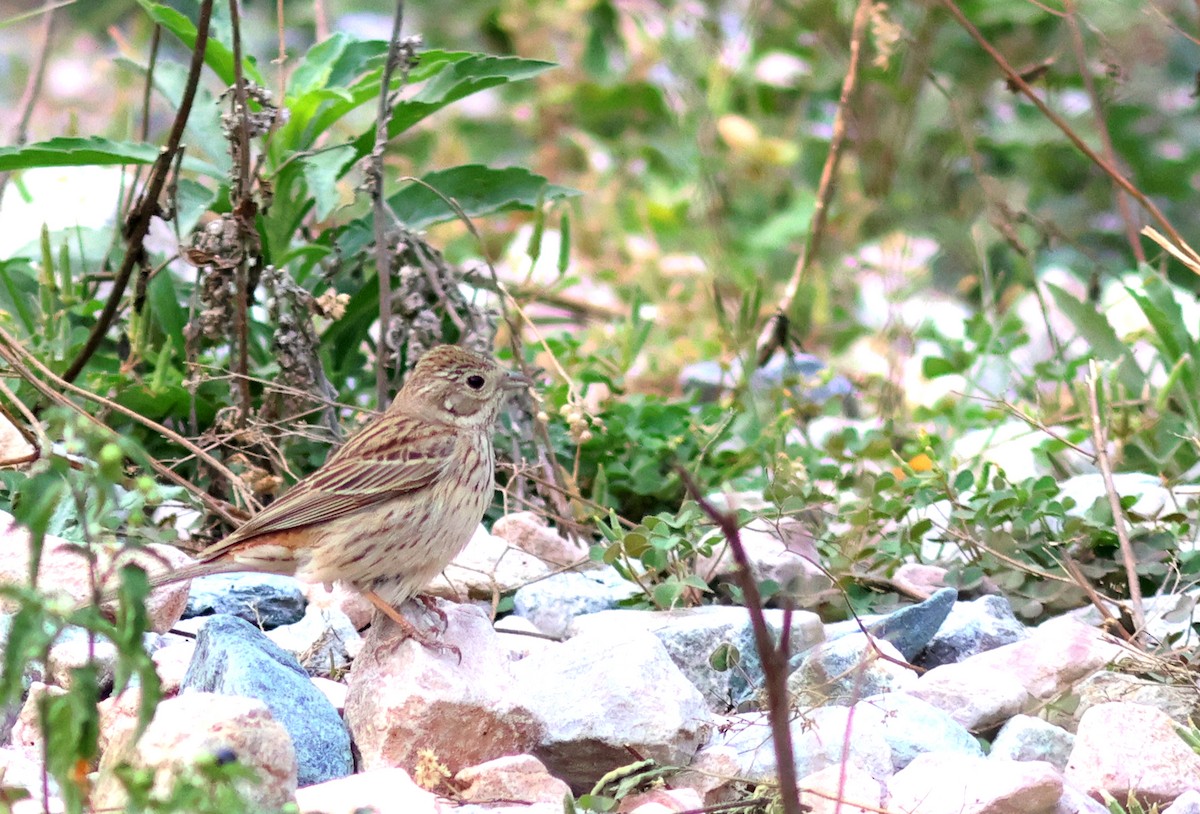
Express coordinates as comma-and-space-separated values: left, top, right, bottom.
676, 467, 804, 814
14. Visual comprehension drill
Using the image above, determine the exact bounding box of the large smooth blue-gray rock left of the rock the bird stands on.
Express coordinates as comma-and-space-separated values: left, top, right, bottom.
180, 614, 354, 786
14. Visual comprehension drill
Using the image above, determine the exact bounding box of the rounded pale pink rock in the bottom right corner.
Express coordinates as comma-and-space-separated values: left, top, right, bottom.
1066, 702, 1200, 804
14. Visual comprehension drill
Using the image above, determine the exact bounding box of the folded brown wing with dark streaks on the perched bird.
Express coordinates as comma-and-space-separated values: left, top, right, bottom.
198, 419, 456, 561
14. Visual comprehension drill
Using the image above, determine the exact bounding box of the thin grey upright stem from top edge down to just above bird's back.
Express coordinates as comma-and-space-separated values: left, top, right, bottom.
367, 0, 404, 408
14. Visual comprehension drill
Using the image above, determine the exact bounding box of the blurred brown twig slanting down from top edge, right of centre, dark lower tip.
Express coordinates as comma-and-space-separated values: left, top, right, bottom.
758, 0, 875, 366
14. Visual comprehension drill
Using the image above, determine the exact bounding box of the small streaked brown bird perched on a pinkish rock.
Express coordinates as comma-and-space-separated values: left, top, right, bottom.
151, 345, 530, 644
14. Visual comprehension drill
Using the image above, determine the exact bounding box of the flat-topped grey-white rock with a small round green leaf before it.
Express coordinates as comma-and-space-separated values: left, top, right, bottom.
571, 605, 824, 713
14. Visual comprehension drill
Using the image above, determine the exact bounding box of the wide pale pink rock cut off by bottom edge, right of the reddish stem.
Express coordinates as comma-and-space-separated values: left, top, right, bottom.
888, 752, 1063, 814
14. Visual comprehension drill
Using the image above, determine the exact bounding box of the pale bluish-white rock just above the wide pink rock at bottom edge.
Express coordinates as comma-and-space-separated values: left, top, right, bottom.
854, 693, 983, 772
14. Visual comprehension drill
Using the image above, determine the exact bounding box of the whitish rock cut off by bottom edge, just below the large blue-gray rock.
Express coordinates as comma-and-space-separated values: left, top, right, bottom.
296, 767, 440, 814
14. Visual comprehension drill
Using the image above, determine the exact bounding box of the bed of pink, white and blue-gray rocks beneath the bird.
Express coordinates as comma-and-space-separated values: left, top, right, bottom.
0, 506, 1200, 814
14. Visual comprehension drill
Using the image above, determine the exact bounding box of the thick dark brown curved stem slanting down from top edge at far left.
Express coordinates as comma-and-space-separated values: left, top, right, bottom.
62, 0, 212, 382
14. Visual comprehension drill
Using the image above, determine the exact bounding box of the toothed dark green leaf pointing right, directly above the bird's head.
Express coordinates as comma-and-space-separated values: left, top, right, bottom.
388, 164, 580, 229
